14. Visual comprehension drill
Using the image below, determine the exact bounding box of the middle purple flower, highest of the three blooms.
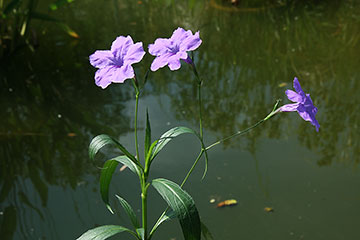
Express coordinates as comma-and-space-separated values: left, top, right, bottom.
149, 27, 202, 71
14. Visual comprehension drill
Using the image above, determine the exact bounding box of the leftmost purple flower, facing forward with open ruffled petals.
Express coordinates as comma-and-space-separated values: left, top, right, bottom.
89, 36, 145, 88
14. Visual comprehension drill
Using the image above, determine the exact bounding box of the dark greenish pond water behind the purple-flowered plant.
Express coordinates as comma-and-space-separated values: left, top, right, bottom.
0, 0, 360, 240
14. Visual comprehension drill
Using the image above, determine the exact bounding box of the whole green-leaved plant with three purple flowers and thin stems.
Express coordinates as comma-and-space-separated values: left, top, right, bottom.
78, 28, 320, 240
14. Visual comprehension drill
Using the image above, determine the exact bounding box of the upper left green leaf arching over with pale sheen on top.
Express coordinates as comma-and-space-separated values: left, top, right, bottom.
89, 134, 138, 164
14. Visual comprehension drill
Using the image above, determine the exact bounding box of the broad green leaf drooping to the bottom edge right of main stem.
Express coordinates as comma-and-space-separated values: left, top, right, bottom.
152, 178, 201, 240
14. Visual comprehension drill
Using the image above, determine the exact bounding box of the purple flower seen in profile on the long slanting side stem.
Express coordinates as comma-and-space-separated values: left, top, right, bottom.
279, 78, 320, 131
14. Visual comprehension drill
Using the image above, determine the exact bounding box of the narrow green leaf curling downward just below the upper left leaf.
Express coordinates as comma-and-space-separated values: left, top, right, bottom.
100, 156, 142, 213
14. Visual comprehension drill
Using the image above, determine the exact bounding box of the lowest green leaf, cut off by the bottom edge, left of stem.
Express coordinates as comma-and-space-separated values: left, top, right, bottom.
77, 225, 137, 240
